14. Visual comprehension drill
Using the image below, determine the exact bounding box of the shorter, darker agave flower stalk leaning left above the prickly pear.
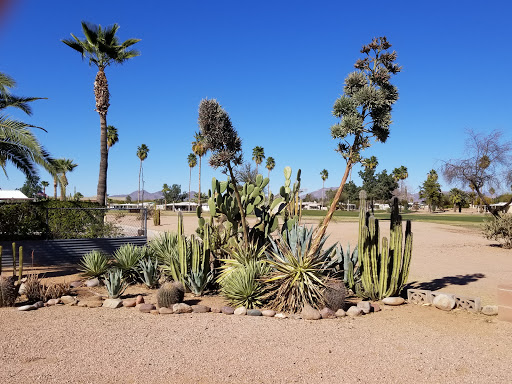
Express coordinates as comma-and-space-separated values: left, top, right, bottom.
199, 99, 249, 246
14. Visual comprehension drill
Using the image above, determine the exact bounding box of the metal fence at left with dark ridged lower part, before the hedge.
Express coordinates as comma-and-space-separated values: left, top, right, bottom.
0, 208, 147, 268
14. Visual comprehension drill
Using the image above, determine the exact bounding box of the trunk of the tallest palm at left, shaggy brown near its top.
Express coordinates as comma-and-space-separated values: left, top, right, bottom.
94, 67, 110, 205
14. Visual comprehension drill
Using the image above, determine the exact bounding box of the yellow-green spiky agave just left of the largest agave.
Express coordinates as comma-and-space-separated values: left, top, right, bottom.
217, 243, 270, 308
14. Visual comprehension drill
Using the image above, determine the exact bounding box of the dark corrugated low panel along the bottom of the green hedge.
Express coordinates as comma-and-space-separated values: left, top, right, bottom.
0, 236, 147, 268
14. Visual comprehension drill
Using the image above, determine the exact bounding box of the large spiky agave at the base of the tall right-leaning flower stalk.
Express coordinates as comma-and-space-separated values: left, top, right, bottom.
266, 224, 335, 312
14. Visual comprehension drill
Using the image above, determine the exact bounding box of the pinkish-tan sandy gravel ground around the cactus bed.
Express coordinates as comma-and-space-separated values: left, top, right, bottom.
0, 212, 512, 383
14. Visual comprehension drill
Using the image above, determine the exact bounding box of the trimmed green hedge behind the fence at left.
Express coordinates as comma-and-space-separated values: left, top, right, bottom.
0, 200, 119, 241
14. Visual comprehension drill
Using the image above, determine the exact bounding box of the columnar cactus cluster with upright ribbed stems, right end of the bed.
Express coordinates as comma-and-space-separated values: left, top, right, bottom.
356, 191, 412, 300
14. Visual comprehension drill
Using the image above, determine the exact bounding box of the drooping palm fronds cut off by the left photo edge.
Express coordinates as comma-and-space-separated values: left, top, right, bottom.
0, 72, 53, 183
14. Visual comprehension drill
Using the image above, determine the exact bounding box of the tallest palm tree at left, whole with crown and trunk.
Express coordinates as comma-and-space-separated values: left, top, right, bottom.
62, 21, 140, 205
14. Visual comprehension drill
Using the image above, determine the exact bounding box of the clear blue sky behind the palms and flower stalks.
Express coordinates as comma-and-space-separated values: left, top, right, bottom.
0, 0, 512, 196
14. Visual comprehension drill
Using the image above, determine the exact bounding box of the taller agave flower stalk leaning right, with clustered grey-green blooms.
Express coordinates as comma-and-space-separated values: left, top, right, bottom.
310, 37, 401, 253
